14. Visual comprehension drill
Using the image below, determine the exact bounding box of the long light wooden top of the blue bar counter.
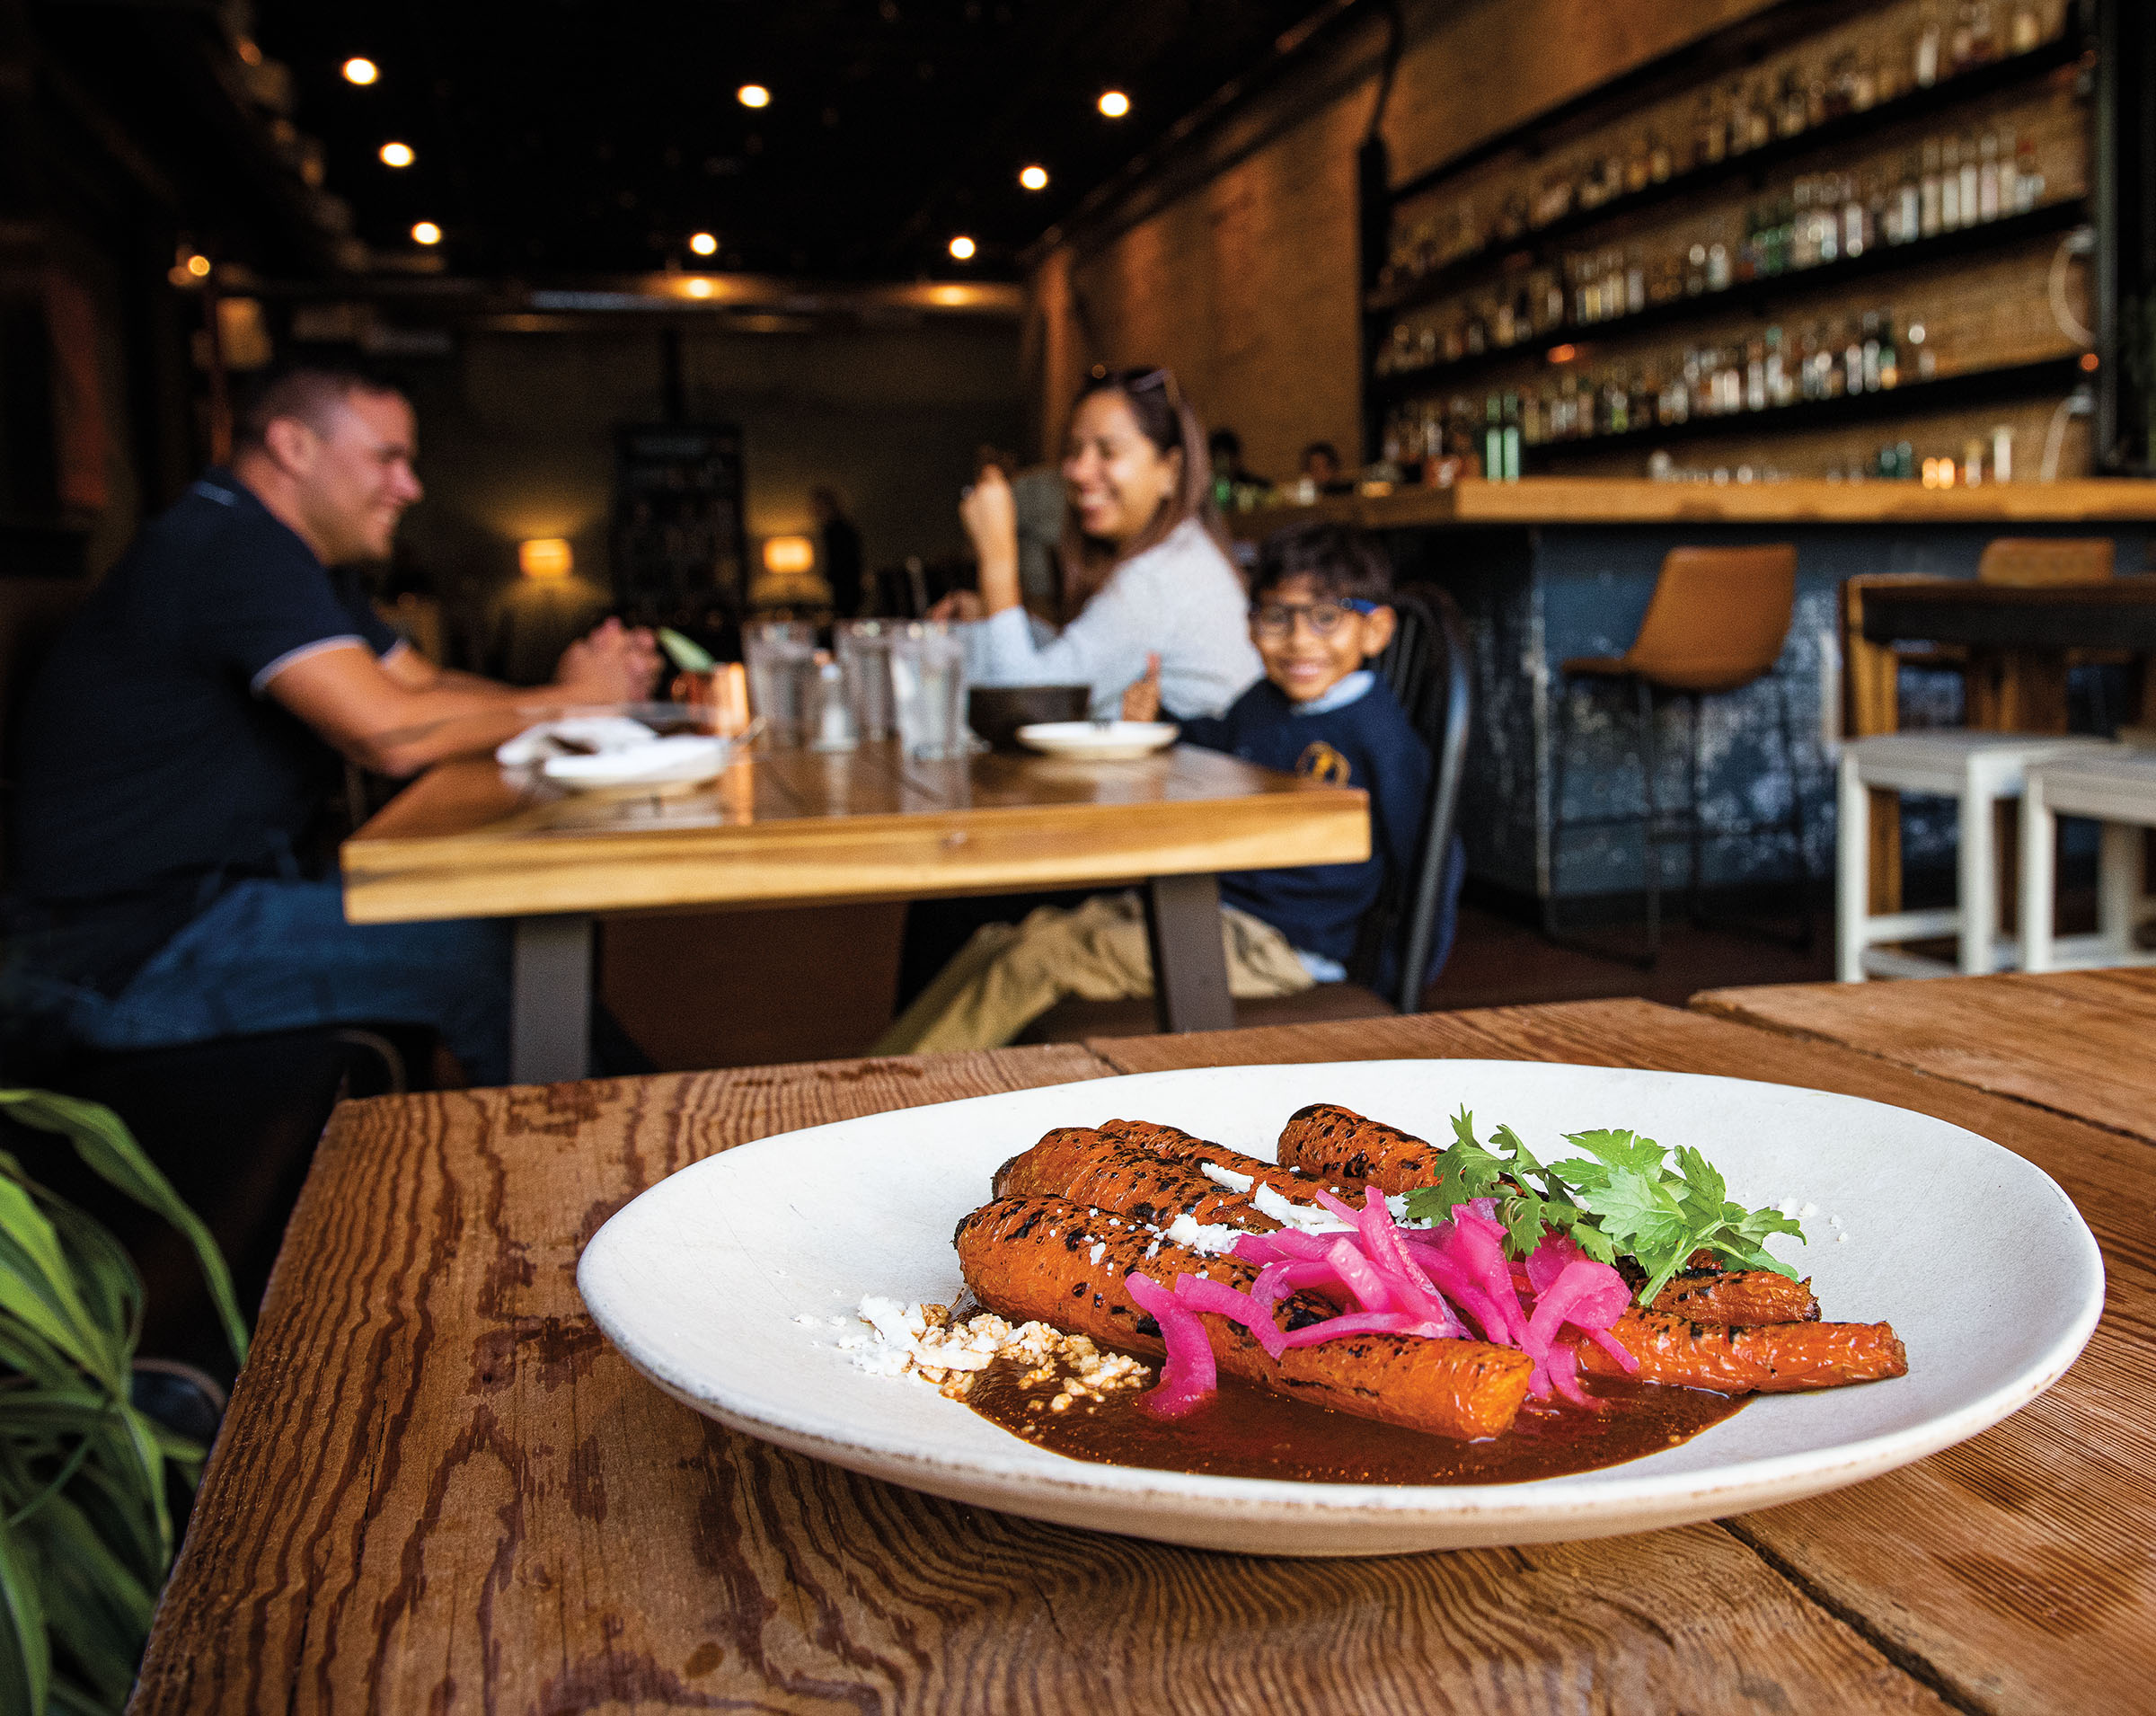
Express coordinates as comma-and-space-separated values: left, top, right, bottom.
1229, 476, 2156, 541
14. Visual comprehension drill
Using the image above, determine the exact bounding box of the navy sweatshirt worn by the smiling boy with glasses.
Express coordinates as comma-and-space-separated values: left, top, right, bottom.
1181, 670, 1429, 964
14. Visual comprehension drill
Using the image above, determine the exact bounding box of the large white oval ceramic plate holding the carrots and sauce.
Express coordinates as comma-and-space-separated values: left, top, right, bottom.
578, 1061, 2104, 1554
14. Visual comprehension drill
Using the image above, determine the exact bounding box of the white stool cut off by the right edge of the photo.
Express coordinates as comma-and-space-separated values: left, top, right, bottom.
2020, 746, 2156, 972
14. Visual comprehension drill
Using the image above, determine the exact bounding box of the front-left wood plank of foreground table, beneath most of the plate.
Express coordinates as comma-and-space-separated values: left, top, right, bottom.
134, 1022, 1951, 1716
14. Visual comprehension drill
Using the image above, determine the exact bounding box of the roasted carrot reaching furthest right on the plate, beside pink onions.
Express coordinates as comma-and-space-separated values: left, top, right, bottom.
1580, 1311, 1908, 1394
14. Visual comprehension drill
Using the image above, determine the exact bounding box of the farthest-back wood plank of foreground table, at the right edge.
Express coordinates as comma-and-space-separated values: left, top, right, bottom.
1692, 968, 2156, 1143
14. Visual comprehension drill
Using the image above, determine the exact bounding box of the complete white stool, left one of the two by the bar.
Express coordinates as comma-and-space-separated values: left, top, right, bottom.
1834, 729, 2111, 983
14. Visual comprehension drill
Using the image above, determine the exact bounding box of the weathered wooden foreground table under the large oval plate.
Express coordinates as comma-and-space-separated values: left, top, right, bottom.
134, 972, 2156, 1716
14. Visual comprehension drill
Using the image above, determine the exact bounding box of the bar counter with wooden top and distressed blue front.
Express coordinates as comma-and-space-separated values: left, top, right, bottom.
1233, 476, 2156, 899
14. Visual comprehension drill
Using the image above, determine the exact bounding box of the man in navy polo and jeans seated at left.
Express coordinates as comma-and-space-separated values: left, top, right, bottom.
0, 367, 658, 1084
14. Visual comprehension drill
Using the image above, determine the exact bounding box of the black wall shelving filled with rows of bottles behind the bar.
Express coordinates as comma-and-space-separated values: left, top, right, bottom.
1367, 0, 2090, 481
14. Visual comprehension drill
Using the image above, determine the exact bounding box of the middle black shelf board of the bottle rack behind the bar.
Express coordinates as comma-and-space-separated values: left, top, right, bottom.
1369, 196, 2090, 408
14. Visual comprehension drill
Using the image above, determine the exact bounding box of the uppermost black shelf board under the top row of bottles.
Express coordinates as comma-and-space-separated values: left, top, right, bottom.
1365, 34, 2087, 314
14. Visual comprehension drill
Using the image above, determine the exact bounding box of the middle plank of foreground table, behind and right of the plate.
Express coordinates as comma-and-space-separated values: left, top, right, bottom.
1093, 1004, 2156, 1712
